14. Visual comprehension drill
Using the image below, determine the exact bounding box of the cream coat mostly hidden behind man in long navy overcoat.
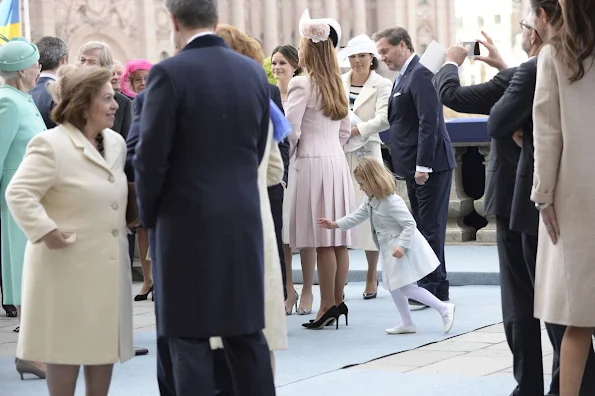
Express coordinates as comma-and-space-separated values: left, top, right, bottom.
210, 124, 287, 351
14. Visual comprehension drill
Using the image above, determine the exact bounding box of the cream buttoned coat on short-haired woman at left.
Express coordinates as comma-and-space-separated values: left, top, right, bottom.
6, 125, 134, 365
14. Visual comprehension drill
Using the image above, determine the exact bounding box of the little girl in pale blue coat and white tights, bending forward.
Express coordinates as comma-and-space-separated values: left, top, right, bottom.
318, 157, 455, 334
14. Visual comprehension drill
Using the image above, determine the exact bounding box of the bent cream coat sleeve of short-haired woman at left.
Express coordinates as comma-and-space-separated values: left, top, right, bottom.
6, 134, 58, 243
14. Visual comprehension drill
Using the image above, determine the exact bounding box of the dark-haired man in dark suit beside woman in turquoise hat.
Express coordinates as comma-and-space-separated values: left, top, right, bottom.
29, 36, 68, 129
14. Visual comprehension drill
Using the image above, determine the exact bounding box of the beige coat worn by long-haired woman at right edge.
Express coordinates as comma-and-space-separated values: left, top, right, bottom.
531, 45, 595, 327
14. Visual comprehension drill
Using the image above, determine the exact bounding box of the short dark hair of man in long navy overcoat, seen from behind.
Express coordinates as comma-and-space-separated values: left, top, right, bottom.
165, 0, 219, 29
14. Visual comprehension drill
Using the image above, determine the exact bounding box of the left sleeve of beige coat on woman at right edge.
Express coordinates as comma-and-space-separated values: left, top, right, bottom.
531, 45, 564, 204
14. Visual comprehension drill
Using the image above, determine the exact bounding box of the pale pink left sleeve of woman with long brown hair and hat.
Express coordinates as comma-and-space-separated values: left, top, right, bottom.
285, 76, 308, 158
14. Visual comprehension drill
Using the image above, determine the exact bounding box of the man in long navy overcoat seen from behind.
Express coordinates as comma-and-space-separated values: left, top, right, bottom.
133, 0, 275, 396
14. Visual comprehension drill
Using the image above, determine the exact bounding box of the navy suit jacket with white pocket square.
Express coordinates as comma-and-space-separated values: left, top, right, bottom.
388, 55, 456, 179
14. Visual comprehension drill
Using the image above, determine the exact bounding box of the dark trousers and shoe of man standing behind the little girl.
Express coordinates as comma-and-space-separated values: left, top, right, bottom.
407, 170, 452, 300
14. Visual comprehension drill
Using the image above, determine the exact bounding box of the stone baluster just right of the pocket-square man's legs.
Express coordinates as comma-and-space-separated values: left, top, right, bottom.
448, 146, 475, 242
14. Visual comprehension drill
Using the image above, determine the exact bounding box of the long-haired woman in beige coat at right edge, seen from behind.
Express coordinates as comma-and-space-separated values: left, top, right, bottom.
531, 0, 595, 396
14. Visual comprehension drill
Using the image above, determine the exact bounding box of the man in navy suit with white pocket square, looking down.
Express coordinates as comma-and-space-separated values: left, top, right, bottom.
374, 27, 456, 307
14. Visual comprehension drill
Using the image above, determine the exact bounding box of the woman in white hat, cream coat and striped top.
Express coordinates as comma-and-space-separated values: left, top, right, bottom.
339, 34, 392, 300
